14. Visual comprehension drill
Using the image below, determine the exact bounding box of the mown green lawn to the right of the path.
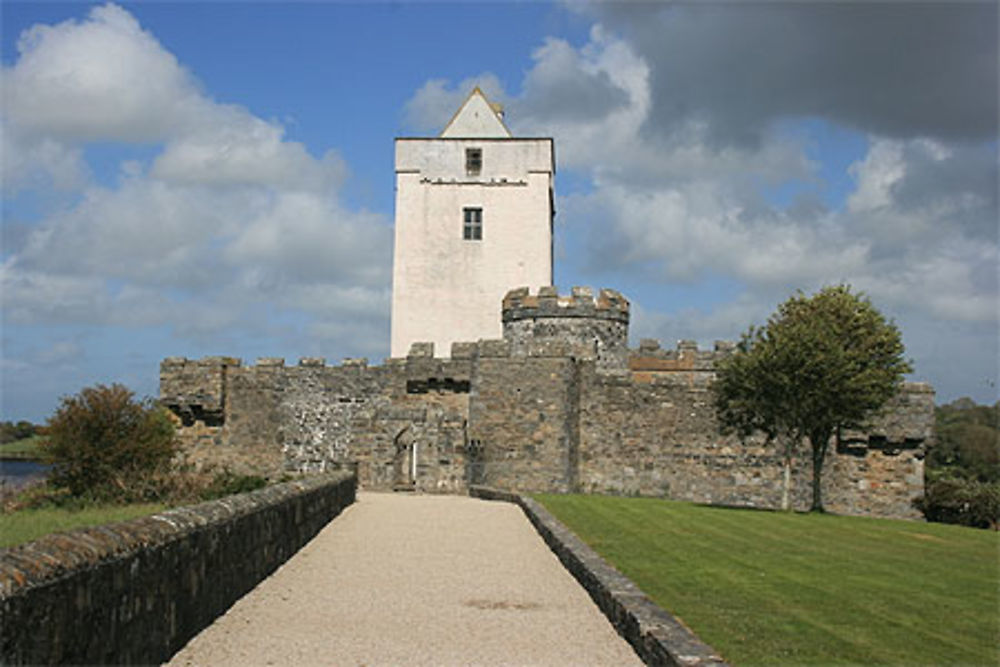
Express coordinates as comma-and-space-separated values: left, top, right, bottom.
537, 495, 1000, 665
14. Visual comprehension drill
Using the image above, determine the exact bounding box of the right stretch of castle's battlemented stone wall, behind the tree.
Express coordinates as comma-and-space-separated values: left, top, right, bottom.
579, 352, 934, 518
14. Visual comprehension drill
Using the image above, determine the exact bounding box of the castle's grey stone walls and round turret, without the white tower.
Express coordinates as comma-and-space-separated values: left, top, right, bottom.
160, 288, 934, 518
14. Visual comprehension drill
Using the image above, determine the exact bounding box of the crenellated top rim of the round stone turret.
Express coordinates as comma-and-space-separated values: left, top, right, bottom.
501, 287, 629, 326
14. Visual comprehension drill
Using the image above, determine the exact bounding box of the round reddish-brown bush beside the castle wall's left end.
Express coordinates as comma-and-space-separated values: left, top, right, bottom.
43, 384, 177, 500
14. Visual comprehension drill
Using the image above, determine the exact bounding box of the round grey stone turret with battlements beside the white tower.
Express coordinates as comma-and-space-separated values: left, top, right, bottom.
502, 287, 629, 369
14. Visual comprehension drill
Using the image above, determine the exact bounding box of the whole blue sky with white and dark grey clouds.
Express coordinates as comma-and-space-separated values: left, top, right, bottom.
0, 0, 1000, 422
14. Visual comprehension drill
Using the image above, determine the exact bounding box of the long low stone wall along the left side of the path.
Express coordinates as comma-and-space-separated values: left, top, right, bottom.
0, 473, 356, 664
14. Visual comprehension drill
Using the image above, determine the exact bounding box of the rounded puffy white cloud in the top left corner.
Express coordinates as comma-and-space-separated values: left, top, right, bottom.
3, 4, 203, 142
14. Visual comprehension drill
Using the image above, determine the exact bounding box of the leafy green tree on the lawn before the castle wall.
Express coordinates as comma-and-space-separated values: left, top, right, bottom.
713, 285, 911, 512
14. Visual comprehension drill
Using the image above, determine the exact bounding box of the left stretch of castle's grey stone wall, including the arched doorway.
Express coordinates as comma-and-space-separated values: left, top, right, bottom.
160, 358, 471, 493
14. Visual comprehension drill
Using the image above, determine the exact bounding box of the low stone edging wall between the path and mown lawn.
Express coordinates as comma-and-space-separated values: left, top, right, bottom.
469, 486, 726, 667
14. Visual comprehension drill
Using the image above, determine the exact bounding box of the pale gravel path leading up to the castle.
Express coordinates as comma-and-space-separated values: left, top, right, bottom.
170, 493, 641, 666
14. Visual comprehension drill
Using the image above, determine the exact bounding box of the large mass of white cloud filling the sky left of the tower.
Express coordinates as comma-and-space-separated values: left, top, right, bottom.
2, 5, 391, 350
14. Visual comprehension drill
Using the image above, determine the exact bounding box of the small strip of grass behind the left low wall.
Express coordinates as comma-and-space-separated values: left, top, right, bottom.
0, 503, 167, 547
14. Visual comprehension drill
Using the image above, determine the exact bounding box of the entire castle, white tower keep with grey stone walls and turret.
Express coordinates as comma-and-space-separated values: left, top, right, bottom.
160, 90, 934, 517
